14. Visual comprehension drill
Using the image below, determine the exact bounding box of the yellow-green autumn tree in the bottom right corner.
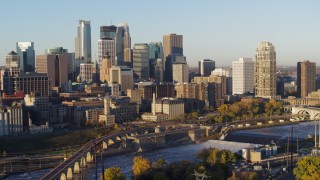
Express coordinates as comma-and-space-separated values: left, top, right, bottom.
293, 156, 320, 179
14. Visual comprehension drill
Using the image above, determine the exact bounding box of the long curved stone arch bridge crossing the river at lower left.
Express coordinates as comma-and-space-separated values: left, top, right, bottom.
41, 124, 212, 180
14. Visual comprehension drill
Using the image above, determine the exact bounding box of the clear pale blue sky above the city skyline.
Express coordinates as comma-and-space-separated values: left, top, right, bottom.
0, 0, 320, 67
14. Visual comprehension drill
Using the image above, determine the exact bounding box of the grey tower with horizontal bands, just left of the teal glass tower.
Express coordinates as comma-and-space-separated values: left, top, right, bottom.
133, 43, 150, 81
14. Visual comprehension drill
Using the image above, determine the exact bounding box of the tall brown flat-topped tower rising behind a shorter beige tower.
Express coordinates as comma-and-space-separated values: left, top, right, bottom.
163, 34, 183, 82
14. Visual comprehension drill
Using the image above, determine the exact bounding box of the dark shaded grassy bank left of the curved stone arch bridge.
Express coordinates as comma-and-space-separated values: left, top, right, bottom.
0, 128, 110, 155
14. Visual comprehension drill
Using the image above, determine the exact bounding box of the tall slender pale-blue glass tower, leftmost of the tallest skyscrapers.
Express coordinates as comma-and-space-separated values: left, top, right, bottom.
75, 20, 91, 67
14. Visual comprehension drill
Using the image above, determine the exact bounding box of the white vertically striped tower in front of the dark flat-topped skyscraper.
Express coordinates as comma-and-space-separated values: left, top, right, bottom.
98, 38, 116, 66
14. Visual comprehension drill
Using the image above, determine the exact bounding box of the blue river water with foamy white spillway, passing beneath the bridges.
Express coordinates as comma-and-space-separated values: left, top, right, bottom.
6, 122, 314, 180
